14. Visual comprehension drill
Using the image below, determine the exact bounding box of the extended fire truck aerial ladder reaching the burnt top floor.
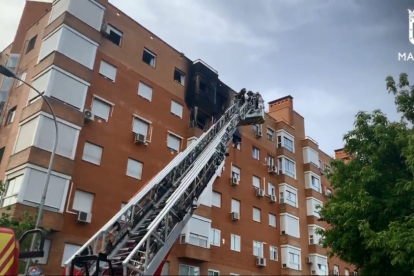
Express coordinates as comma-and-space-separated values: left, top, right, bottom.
63, 89, 264, 276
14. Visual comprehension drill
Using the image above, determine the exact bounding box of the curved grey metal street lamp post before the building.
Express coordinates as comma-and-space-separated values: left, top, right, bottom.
0, 65, 58, 273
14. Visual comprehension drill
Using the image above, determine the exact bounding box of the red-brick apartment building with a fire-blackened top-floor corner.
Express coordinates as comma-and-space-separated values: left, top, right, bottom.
0, 0, 353, 275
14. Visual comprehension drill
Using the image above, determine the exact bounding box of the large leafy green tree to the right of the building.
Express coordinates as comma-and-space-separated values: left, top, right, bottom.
319, 73, 414, 275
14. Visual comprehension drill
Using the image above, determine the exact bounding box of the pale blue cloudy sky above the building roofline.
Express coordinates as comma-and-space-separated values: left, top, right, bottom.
0, 0, 414, 155
